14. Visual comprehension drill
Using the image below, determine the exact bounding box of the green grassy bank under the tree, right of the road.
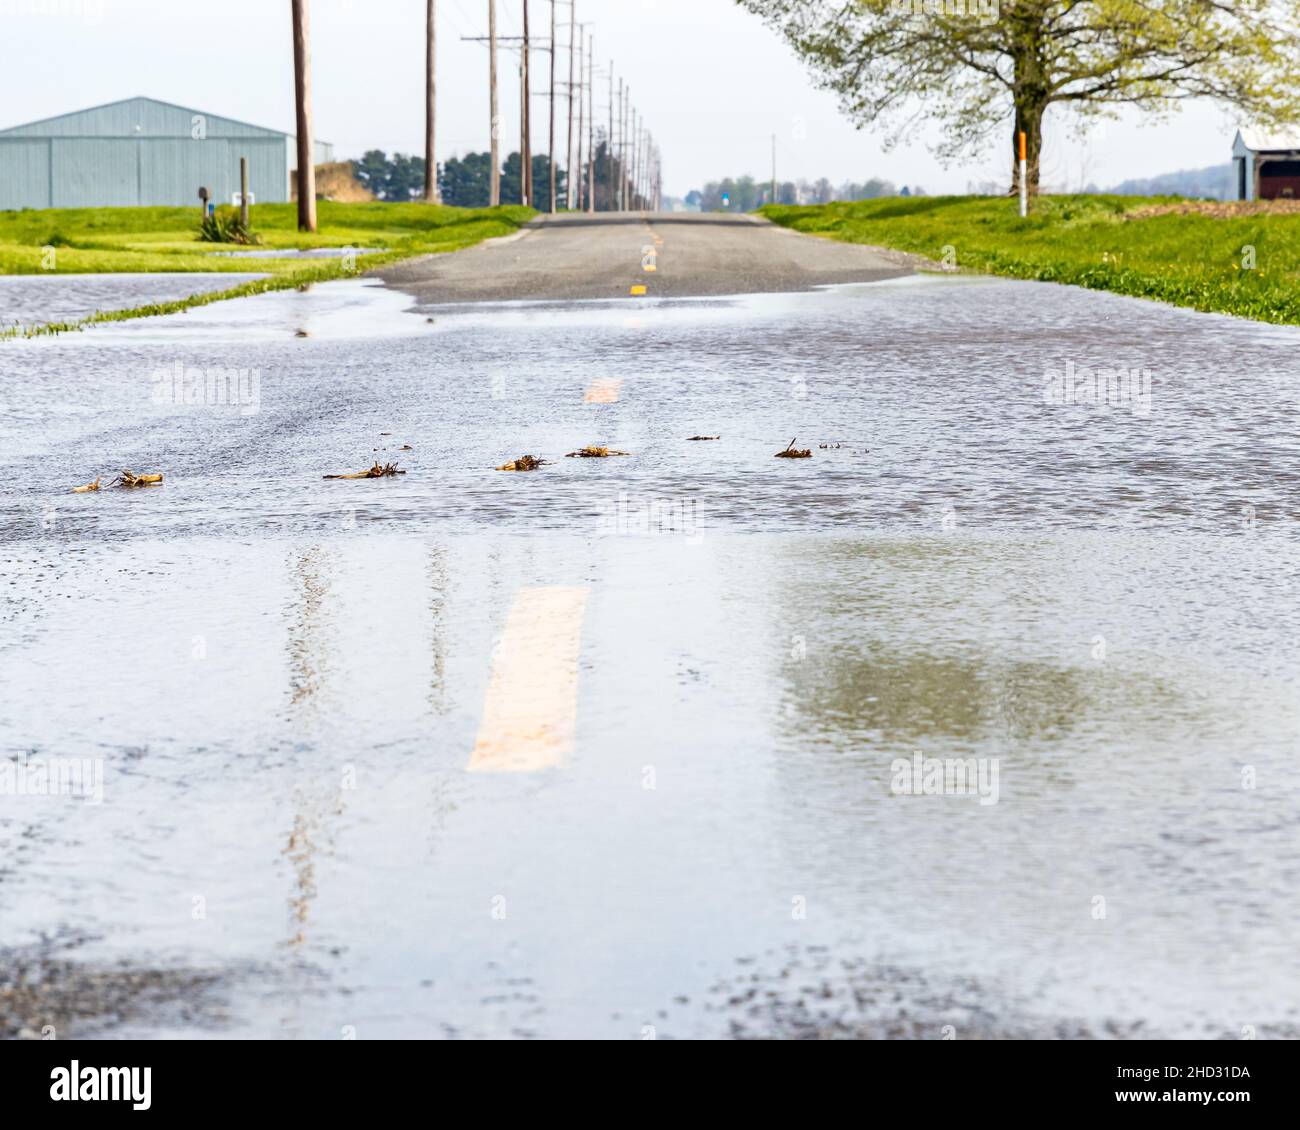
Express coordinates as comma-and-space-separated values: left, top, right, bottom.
762, 196, 1300, 325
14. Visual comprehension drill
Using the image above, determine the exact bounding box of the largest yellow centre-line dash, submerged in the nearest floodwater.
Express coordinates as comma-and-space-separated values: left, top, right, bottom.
465, 586, 589, 772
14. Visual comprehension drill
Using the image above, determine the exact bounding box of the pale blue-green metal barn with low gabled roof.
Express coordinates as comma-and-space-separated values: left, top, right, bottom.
0, 98, 334, 209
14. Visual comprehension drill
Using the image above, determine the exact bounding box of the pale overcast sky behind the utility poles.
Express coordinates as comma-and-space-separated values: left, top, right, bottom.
0, 0, 1235, 195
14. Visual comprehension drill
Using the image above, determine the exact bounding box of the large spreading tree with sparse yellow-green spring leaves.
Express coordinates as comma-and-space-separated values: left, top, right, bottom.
737, 0, 1300, 192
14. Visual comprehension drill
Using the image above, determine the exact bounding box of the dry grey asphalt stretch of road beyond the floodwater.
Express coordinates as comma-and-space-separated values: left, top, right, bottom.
378, 212, 910, 304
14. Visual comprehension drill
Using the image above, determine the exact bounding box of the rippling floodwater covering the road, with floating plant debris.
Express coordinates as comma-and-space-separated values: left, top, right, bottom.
0, 277, 1300, 1039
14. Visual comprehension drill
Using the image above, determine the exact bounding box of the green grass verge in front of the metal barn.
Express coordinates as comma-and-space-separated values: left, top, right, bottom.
0, 200, 536, 338
